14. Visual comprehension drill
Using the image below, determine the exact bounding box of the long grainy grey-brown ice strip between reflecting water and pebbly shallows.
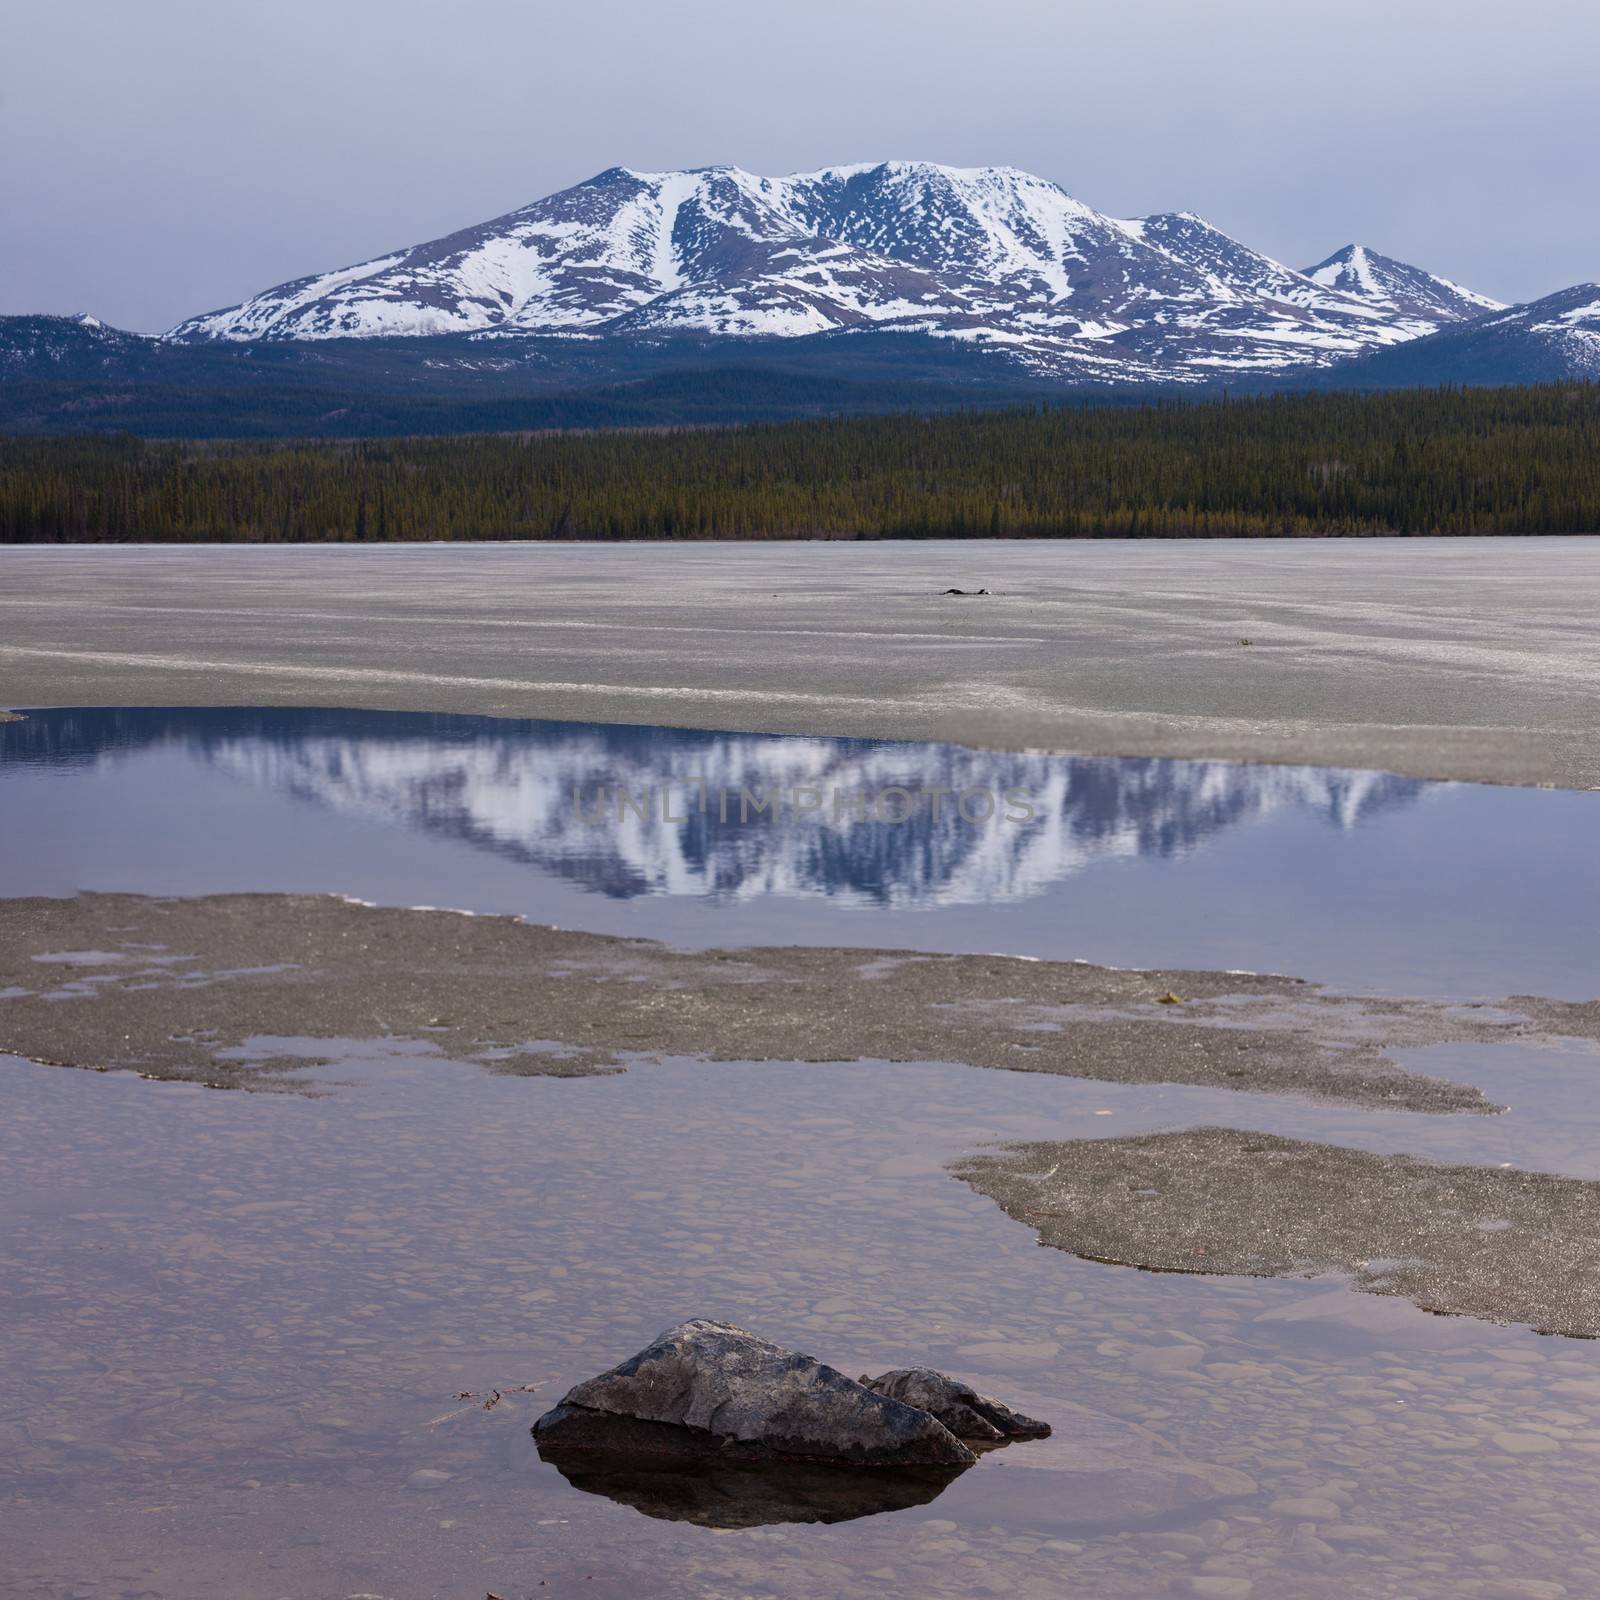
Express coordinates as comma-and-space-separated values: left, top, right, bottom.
0, 894, 1600, 1115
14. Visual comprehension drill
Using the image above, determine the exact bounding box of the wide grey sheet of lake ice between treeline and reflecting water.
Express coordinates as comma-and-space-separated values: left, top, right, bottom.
9, 536, 1600, 789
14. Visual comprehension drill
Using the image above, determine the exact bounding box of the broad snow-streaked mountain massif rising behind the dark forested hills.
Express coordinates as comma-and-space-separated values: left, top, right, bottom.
168, 162, 1496, 384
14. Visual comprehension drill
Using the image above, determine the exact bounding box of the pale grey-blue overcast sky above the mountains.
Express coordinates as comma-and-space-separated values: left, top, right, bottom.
9, 0, 1600, 331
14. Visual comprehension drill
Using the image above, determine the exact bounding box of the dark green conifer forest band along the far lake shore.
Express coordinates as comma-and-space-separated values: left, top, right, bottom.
0, 384, 1600, 542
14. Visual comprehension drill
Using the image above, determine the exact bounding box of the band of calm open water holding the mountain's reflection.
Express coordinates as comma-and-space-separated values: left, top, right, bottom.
0, 709, 1600, 998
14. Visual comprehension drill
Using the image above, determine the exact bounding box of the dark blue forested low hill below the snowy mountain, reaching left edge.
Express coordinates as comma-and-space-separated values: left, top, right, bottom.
0, 317, 1088, 438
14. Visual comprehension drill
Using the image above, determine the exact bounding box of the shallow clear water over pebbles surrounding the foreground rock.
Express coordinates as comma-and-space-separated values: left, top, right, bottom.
9, 1049, 1600, 1600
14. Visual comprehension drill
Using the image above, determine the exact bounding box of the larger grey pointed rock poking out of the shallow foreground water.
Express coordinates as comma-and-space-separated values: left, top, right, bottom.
533, 1318, 978, 1467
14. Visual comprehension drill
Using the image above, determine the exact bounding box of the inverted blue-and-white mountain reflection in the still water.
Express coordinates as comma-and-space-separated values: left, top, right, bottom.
0, 709, 1434, 907
